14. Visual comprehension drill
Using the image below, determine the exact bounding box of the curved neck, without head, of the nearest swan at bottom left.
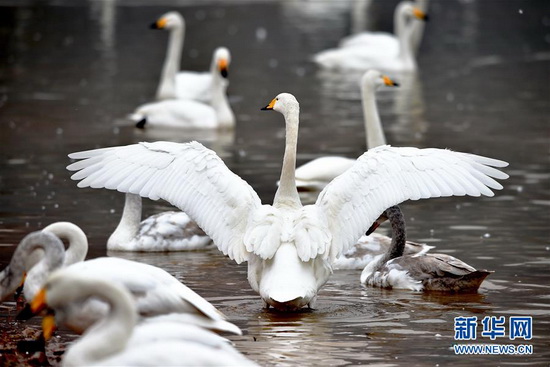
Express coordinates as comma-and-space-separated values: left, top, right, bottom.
63, 282, 137, 366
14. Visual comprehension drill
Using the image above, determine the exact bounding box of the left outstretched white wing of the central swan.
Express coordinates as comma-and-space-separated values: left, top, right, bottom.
67, 141, 261, 263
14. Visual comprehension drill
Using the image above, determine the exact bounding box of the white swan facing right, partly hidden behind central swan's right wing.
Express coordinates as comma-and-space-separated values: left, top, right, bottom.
296, 70, 398, 190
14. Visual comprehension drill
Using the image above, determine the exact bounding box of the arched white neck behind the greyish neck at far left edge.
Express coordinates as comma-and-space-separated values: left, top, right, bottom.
43, 222, 88, 267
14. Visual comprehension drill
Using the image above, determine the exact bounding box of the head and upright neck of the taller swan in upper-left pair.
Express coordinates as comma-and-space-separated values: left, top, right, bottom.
151, 11, 185, 101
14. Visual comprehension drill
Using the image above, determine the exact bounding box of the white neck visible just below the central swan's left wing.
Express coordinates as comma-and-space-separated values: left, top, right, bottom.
107, 193, 142, 246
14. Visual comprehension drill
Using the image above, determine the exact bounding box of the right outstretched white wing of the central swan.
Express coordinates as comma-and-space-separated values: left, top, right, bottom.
315, 145, 508, 264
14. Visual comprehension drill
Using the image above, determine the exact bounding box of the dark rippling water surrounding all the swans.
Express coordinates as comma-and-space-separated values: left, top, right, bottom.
0, 0, 550, 366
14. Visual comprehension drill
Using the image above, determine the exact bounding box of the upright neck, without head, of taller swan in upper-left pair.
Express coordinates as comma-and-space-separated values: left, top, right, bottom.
157, 25, 185, 101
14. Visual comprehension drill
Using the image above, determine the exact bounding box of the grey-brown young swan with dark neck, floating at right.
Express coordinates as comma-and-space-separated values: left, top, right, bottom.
361, 206, 491, 292
